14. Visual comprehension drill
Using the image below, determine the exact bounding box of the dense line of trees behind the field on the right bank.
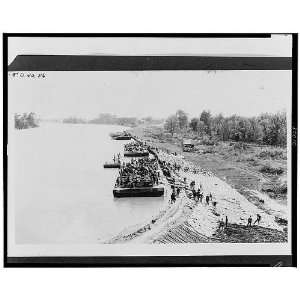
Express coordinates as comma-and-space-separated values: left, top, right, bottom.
164, 110, 287, 146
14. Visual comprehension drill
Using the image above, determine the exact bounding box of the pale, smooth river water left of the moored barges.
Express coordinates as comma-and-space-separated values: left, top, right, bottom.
9, 123, 166, 244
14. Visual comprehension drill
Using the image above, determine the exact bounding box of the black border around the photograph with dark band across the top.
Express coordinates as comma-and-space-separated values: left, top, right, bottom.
3, 33, 298, 267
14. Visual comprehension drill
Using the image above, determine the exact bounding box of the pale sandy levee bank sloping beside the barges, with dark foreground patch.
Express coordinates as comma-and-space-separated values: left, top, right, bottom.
106, 126, 287, 243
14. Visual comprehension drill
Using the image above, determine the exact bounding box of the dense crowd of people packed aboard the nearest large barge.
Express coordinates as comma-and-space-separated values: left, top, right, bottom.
116, 157, 160, 188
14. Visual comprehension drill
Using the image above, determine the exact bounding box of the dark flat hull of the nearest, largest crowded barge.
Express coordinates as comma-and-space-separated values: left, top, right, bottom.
113, 185, 165, 198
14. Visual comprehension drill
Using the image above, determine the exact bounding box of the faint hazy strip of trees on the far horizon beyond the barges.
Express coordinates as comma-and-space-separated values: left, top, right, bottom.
63, 113, 163, 127
